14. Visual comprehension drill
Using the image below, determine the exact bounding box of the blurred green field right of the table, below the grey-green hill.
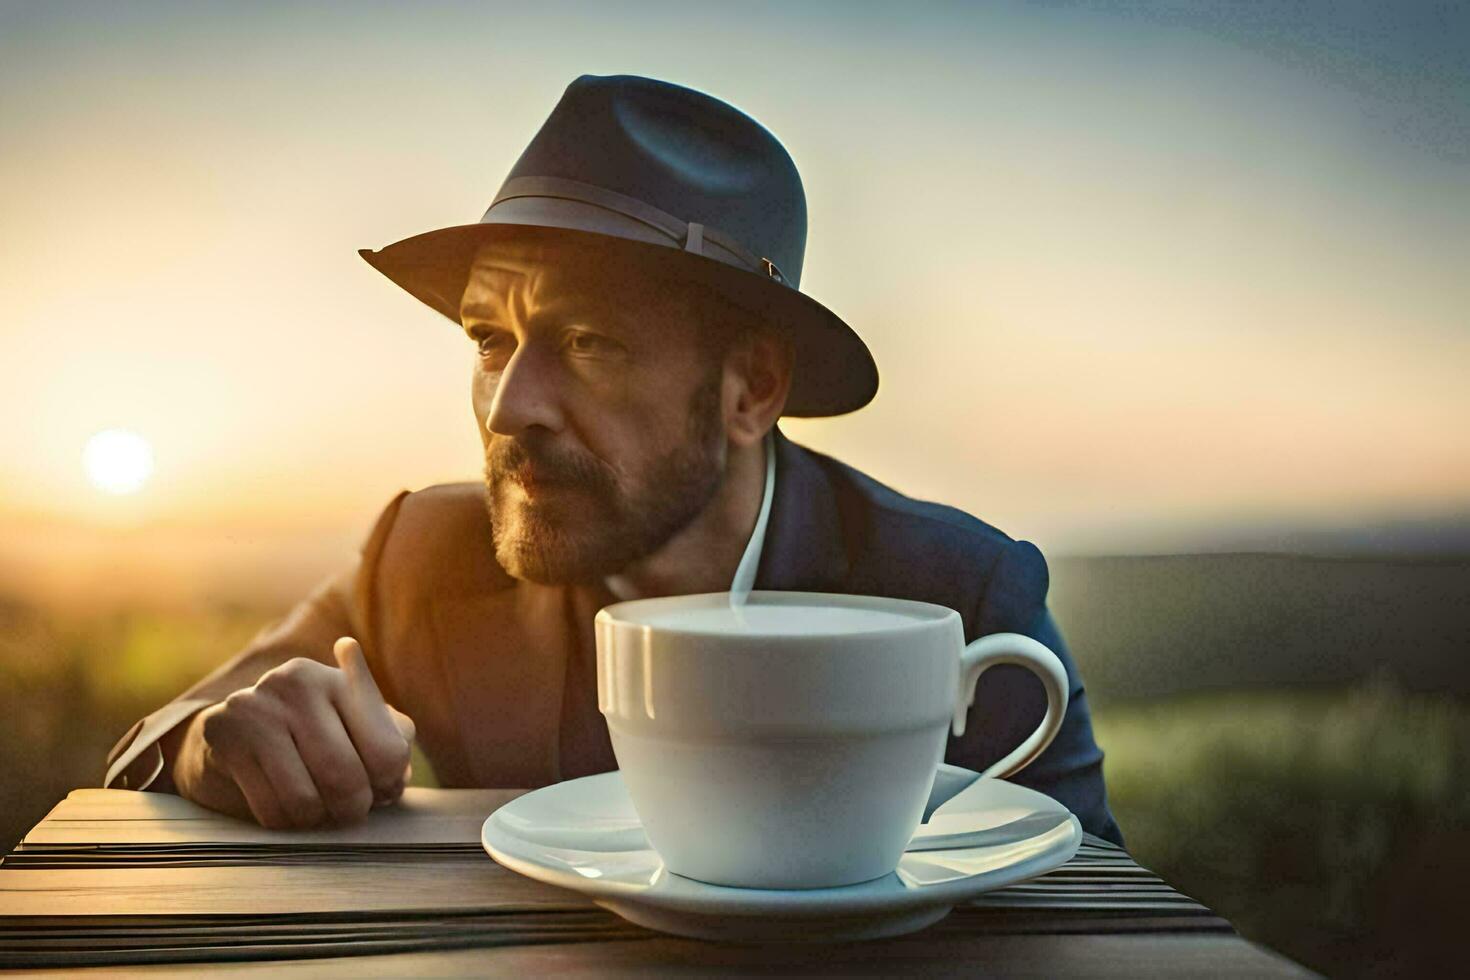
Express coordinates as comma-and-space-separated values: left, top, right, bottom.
1097, 682, 1470, 977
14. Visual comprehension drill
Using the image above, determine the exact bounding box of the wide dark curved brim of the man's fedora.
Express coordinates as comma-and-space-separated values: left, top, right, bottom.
359, 222, 878, 417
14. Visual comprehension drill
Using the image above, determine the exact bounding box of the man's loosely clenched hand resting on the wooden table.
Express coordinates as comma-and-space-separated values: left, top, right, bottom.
173, 636, 415, 830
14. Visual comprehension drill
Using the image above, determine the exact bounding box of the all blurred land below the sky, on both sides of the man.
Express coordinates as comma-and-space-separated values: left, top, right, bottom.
0, 555, 1470, 976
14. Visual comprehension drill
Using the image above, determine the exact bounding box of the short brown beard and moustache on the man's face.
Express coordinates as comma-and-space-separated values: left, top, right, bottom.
485, 372, 725, 585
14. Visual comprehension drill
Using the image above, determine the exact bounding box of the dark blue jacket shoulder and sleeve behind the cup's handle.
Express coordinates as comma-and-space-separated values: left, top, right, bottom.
756, 428, 1123, 845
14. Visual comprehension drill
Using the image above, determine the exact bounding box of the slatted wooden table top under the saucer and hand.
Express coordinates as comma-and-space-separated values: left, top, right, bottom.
0, 788, 1311, 977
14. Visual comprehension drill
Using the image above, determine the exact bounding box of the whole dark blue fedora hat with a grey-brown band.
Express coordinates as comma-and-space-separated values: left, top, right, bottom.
359, 75, 878, 416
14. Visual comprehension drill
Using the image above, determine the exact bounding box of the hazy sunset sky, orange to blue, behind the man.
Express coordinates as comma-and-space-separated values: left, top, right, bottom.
0, 0, 1470, 602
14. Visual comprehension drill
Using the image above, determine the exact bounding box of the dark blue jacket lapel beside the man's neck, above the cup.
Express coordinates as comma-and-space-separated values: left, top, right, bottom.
756, 426, 848, 592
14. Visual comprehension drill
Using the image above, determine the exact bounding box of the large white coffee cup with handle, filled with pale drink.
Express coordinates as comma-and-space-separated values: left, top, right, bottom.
595, 592, 1067, 889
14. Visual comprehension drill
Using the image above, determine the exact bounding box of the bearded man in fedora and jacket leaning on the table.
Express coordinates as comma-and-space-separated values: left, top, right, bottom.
107, 75, 1122, 842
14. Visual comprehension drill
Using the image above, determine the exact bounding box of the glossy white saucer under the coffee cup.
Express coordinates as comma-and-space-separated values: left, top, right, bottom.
481, 765, 1082, 942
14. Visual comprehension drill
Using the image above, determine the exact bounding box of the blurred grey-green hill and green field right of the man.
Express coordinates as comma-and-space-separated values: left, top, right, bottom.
1051, 554, 1470, 977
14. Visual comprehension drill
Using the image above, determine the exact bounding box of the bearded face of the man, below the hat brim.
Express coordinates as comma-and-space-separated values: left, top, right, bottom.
460, 245, 726, 583
